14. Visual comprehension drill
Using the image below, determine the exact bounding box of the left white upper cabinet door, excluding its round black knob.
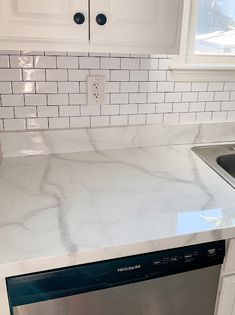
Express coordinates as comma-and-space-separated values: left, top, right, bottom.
0, 0, 89, 43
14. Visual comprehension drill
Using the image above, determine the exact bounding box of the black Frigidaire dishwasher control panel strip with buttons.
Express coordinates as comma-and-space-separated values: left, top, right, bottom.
7, 241, 225, 307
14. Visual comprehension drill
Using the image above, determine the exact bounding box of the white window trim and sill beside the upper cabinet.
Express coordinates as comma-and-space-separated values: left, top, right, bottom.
170, 0, 235, 81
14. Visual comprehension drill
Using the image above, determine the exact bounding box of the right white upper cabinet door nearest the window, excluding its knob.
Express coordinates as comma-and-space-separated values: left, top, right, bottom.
90, 0, 183, 53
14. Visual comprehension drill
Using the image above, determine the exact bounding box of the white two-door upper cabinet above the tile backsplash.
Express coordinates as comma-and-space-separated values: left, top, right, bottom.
0, 0, 183, 54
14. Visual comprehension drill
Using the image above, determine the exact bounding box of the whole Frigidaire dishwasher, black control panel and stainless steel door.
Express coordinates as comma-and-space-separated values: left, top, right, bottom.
7, 241, 225, 315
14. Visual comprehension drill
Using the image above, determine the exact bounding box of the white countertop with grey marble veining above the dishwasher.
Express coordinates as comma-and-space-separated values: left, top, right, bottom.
0, 145, 235, 277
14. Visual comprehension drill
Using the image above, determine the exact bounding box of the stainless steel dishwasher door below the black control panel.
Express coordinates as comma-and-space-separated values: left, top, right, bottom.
12, 265, 220, 315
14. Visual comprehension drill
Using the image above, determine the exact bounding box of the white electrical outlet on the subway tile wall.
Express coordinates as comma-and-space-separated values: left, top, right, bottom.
87, 75, 105, 105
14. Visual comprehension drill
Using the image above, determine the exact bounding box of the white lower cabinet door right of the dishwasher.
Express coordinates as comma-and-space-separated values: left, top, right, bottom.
216, 275, 235, 315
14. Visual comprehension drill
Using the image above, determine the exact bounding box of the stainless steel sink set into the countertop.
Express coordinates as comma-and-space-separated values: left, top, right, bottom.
192, 143, 235, 188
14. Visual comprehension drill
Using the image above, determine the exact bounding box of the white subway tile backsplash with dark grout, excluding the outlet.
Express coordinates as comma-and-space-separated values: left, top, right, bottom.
0, 51, 235, 130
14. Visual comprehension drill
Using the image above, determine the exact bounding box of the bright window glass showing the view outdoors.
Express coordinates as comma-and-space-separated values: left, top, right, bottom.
195, 0, 235, 55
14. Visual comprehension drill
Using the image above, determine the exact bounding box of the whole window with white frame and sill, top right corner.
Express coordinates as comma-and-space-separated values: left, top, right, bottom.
172, 0, 235, 81
